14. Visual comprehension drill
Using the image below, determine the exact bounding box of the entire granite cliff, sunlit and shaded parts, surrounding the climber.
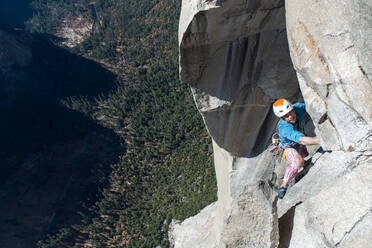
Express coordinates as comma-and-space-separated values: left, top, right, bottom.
171, 0, 372, 248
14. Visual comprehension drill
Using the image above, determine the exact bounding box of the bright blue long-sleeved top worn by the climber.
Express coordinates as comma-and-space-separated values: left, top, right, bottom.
277, 103, 306, 149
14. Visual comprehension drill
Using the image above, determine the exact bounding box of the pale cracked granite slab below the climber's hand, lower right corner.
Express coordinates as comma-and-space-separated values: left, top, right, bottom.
278, 152, 372, 248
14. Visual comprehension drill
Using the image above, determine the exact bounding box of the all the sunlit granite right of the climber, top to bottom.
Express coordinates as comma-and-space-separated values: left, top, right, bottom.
278, 0, 372, 248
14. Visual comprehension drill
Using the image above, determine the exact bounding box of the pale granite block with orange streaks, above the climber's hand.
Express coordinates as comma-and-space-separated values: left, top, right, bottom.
286, 0, 372, 151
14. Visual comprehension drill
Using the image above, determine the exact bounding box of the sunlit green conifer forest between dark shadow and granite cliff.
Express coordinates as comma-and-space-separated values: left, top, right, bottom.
26, 0, 217, 248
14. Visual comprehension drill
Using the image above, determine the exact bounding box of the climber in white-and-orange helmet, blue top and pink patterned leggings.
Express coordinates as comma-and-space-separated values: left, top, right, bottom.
273, 98, 320, 199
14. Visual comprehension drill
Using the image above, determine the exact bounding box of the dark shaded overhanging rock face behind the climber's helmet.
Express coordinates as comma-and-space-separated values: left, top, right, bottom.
180, 1, 299, 157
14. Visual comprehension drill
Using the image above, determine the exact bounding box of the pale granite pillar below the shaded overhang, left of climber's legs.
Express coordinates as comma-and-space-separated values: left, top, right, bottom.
171, 142, 279, 247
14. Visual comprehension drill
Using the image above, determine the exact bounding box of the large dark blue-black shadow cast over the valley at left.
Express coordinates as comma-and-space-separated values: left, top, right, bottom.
0, 27, 125, 248
